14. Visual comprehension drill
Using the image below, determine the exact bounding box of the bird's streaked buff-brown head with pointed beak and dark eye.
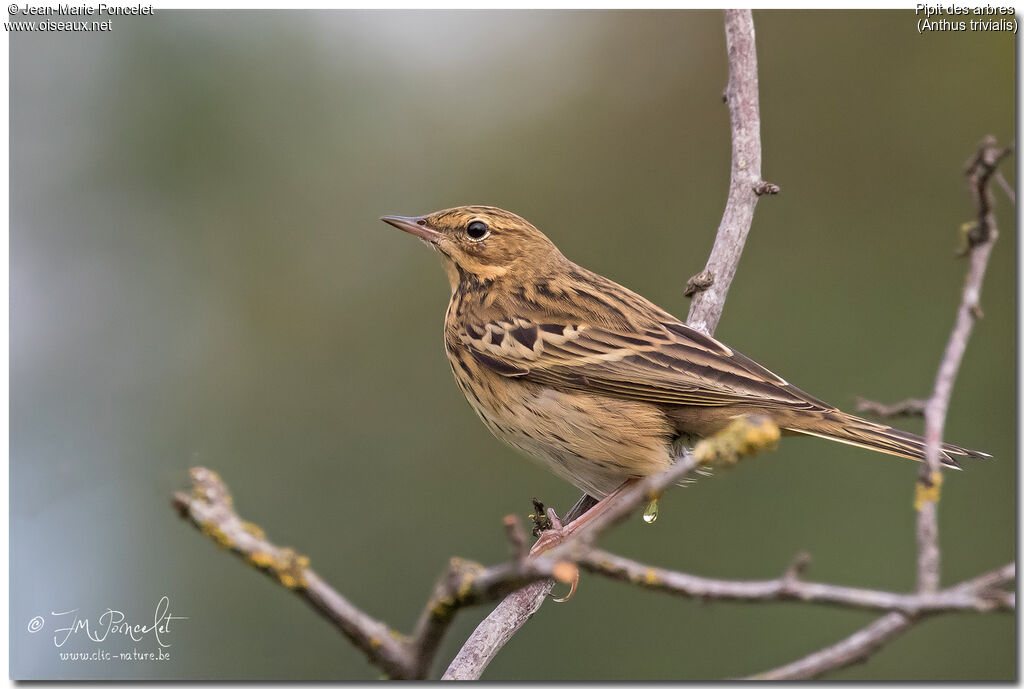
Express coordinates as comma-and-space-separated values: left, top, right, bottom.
381, 206, 564, 290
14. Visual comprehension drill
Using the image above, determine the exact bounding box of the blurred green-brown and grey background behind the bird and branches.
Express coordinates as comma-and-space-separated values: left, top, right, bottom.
10, 10, 1017, 680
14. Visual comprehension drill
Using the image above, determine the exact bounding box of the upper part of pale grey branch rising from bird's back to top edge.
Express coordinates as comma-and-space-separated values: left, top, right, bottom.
686, 9, 778, 335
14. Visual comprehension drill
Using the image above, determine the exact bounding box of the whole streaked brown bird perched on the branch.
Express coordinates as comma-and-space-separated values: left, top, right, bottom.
381, 206, 988, 505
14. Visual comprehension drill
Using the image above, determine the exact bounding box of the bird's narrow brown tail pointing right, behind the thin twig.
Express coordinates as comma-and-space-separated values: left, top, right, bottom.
779, 410, 991, 469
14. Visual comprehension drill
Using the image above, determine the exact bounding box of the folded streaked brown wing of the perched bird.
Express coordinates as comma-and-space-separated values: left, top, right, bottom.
458, 317, 833, 410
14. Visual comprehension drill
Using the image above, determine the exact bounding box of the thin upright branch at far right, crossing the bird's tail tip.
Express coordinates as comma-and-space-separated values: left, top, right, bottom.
914, 136, 1013, 593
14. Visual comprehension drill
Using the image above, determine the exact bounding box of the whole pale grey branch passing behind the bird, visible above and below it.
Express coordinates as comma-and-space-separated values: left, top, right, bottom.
441, 9, 778, 680
